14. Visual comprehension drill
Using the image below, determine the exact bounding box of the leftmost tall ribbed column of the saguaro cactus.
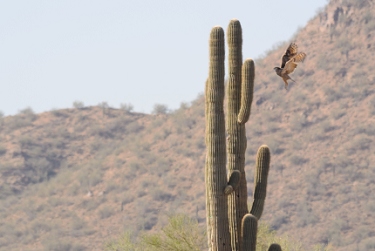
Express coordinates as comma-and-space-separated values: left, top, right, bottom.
205, 27, 231, 251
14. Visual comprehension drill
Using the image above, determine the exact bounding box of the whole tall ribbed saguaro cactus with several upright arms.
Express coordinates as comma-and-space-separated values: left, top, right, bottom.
205, 20, 280, 251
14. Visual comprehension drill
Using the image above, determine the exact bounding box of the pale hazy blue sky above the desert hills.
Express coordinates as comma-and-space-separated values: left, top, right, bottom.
0, 0, 327, 115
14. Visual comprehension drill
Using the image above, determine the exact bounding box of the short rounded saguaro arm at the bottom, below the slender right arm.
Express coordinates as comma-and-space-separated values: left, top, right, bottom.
241, 214, 258, 251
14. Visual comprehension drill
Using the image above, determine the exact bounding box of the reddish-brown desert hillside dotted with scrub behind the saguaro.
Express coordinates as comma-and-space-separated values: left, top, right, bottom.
0, 0, 375, 250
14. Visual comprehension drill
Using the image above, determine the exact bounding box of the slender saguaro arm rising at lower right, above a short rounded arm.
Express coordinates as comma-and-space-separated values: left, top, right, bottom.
250, 145, 271, 220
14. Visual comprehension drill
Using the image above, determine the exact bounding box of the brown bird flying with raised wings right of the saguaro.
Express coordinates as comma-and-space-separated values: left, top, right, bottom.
273, 42, 306, 89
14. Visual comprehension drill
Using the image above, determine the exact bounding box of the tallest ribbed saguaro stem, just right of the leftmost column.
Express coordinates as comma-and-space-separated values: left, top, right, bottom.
226, 19, 250, 250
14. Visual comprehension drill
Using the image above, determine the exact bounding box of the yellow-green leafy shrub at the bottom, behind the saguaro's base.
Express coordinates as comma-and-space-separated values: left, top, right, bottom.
105, 215, 306, 251
